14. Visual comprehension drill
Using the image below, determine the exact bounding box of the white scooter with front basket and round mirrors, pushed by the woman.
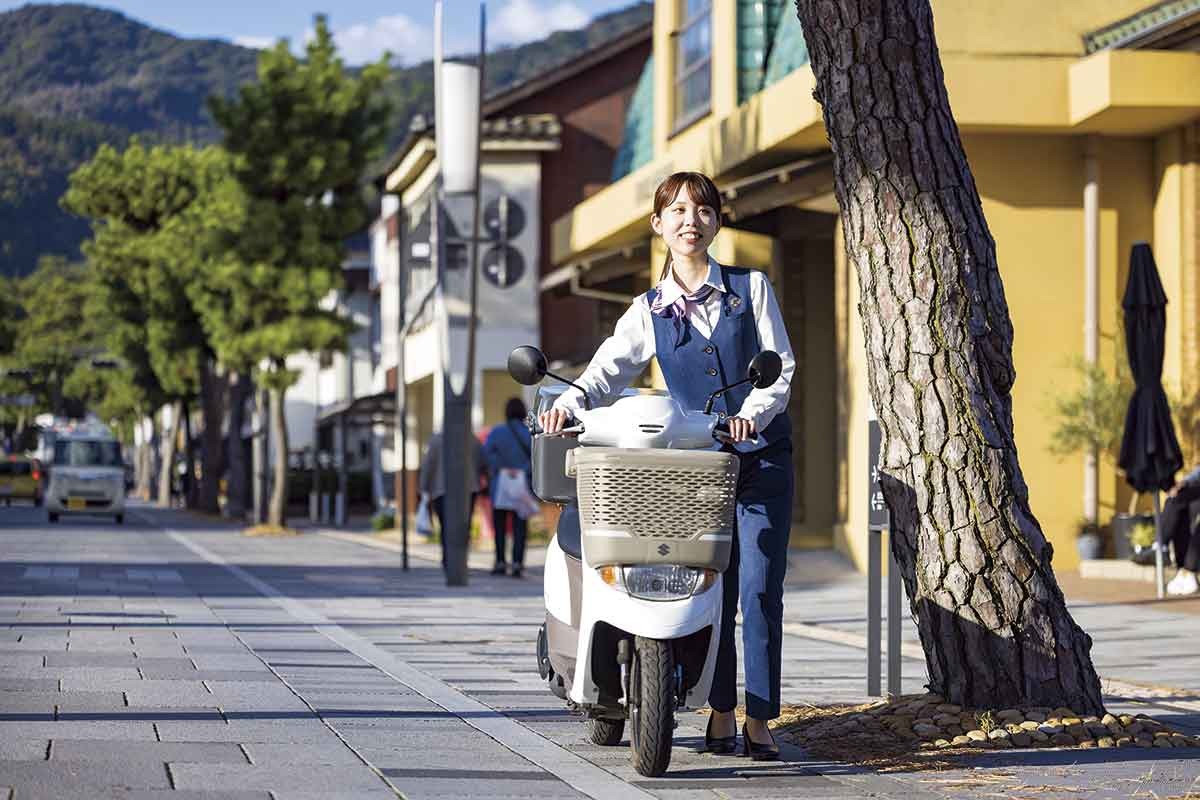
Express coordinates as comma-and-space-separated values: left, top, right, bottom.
509, 347, 781, 776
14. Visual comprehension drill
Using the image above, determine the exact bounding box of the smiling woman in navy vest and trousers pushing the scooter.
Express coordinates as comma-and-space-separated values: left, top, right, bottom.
540, 173, 796, 759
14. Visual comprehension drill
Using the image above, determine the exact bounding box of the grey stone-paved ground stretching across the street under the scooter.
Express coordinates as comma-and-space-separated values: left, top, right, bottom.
0, 509, 1200, 800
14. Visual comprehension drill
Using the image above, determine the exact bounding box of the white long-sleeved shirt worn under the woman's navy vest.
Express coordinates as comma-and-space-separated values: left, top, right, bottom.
554, 257, 796, 441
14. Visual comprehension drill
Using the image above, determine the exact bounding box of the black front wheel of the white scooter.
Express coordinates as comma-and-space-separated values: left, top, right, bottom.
629, 636, 676, 777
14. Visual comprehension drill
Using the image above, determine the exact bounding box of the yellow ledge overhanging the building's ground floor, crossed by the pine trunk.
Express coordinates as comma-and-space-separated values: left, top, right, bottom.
550, 50, 1200, 265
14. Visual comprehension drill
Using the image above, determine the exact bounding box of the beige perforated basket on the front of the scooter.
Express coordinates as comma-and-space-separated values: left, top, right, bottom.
569, 447, 738, 570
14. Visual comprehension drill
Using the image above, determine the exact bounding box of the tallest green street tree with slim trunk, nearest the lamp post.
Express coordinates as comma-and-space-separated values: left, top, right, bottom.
203, 16, 389, 525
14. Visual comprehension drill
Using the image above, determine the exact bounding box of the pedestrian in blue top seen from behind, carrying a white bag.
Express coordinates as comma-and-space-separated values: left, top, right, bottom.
484, 397, 536, 578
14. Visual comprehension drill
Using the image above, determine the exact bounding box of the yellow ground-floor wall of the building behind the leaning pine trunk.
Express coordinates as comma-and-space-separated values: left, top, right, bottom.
836, 136, 1162, 569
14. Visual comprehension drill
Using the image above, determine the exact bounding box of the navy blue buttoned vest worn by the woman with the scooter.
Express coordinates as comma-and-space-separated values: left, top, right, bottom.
646, 266, 792, 447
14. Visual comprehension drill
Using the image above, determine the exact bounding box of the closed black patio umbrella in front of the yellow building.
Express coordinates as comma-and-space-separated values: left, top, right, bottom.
1118, 242, 1183, 492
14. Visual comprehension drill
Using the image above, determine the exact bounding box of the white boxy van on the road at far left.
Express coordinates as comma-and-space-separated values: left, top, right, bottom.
44, 433, 125, 524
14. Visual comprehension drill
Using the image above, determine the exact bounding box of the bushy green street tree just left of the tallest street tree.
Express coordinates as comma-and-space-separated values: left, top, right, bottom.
62, 139, 224, 511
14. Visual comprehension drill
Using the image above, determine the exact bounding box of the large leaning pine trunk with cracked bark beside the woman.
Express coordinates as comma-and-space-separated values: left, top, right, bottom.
796, 0, 1103, 714
